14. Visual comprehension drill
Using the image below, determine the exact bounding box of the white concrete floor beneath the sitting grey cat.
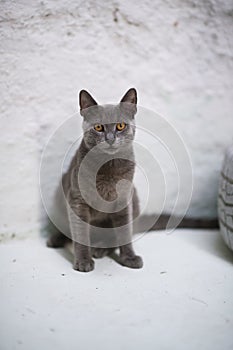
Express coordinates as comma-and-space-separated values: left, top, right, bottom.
0, 230, 233, 350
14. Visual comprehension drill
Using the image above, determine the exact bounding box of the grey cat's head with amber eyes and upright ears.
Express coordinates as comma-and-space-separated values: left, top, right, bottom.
79, 88, 137, 154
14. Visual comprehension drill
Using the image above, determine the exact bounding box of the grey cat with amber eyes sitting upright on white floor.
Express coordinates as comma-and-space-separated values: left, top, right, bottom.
47, 88, 218, 272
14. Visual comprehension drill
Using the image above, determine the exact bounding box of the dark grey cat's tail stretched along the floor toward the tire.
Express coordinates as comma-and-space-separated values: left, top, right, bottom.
137, 214, 219, 232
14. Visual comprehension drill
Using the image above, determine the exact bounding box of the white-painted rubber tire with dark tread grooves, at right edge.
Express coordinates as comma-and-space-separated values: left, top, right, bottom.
218, 146, 233, 250
